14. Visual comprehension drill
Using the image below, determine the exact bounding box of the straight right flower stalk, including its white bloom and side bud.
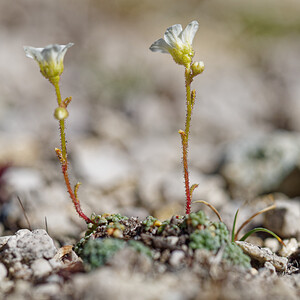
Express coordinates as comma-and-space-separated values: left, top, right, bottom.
150, 21, 204, 214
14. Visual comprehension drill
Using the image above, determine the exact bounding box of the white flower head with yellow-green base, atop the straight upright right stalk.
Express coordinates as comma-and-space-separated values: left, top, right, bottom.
150, 21, 199, 65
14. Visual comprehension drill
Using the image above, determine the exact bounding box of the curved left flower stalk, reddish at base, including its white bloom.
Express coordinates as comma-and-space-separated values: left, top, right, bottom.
24, 43, 93, 223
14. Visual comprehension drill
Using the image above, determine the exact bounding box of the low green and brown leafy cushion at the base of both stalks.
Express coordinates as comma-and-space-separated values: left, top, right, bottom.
75, 211, 250, 269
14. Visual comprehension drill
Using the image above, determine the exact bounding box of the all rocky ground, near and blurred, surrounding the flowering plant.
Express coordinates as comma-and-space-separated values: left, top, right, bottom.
0, 0, 300, 299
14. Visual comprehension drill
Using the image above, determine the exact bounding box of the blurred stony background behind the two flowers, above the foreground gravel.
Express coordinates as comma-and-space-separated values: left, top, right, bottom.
0, 0, 300, 243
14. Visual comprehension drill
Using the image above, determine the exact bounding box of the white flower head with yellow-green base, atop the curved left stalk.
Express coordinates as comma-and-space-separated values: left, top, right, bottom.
24, 43, 74, 81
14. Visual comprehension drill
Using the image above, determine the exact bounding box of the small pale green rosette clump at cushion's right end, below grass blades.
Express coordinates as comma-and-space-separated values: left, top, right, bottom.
223, 243, 251, 268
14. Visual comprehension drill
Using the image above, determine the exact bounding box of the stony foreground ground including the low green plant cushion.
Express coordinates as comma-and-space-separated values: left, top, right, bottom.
0, 211, 300, 299
